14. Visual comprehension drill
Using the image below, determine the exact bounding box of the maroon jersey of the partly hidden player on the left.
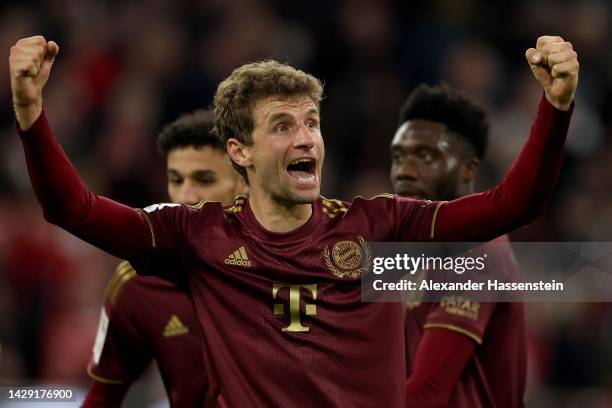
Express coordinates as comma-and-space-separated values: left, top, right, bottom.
87, 261, 208, 407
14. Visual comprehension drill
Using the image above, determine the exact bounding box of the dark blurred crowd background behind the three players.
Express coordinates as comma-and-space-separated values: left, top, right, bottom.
0, 0, 612, 407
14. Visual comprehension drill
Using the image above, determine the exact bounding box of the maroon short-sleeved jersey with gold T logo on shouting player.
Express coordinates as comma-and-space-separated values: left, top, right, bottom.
143, 195, 438, 407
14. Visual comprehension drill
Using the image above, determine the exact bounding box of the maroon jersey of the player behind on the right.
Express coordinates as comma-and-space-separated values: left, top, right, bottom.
406, 236, 527, 408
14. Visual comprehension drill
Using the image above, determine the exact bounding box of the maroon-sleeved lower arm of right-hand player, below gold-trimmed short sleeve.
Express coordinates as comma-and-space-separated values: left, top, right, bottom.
406, 329, 476, 408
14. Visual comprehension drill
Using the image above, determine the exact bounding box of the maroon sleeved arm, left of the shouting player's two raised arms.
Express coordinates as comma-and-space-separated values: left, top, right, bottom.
19, 112, 151, 260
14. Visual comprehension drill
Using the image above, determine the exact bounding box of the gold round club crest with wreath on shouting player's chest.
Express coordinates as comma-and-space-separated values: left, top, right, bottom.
323, 235, 372, 279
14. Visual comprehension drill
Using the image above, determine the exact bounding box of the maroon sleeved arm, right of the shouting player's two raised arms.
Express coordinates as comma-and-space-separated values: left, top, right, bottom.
434, 97, 573, 241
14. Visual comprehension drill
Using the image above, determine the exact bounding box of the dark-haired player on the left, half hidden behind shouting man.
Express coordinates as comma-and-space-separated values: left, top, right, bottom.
83, 110, 246, 408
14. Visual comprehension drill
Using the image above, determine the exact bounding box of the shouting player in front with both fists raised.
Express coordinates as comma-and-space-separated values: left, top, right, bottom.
10, 37, 578, 407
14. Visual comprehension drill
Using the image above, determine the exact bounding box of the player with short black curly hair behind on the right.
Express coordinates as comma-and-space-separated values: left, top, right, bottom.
391, 85, 527, 408
